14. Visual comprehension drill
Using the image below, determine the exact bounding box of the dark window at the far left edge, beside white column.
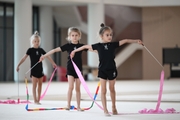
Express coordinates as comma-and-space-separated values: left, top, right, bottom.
0, 2, 14, 81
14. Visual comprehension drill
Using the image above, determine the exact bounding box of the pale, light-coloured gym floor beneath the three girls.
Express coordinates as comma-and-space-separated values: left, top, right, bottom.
0, 79, 180, 120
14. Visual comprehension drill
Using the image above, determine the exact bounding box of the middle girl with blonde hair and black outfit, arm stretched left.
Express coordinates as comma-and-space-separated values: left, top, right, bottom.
40, 27, 87, 111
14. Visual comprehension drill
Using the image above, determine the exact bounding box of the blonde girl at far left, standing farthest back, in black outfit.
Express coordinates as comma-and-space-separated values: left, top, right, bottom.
16, 31, 56, 105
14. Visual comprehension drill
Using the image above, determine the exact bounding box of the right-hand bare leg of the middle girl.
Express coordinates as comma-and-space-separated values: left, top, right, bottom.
76, 79, 83, 111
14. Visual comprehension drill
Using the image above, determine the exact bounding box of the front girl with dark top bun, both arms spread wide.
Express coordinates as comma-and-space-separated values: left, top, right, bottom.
71, 24, 142, 116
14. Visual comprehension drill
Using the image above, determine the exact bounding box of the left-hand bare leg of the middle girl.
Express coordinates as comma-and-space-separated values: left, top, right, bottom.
67, 75, 74, 109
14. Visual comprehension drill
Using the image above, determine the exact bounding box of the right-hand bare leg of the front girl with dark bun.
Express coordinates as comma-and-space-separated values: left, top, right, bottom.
109, 79, 117, 115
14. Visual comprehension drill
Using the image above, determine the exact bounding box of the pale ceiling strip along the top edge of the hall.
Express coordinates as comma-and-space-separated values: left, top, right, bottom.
0, 0, 180, 7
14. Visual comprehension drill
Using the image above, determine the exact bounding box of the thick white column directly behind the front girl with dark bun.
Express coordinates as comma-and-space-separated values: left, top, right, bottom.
88, 1, 104, 80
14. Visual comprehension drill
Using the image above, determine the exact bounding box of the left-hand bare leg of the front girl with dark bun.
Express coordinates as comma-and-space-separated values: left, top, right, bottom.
100, 78, 109, 115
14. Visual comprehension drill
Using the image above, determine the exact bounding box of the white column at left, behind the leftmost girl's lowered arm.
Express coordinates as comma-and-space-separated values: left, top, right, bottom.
14, 0, 32, 81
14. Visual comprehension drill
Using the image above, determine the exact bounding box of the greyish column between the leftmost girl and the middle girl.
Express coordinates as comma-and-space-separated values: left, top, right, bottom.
40, 6, 53, 79
